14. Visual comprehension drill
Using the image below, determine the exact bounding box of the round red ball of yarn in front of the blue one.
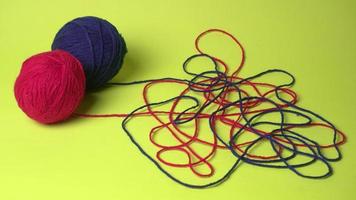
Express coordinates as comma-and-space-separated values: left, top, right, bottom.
14, 50, 85, 124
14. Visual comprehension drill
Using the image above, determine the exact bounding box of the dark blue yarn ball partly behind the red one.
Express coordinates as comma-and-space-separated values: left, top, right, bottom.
52, 16, 127, 89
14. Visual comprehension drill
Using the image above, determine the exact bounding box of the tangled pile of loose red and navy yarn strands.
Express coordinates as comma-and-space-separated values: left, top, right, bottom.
77, 29, 346, 188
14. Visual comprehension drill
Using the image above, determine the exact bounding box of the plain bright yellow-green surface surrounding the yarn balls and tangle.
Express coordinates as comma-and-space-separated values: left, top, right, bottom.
0, 0, 356, 200
